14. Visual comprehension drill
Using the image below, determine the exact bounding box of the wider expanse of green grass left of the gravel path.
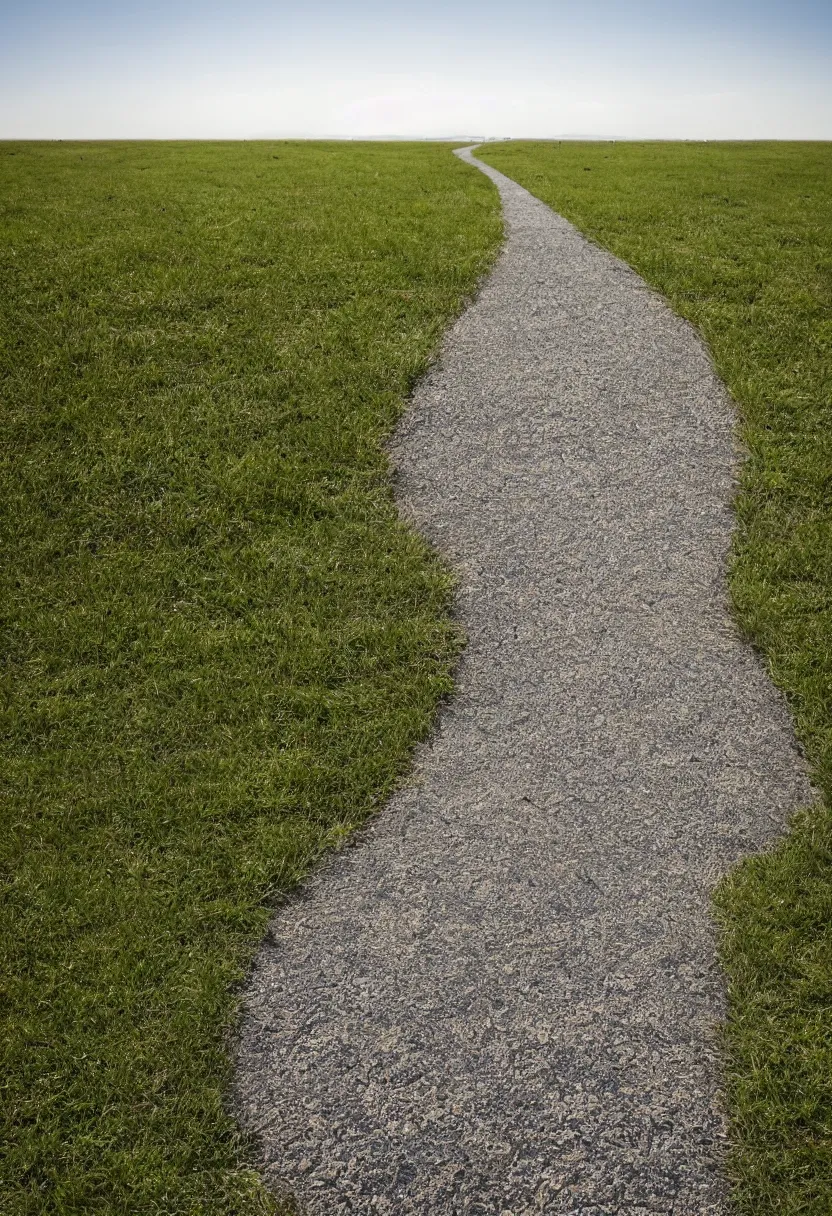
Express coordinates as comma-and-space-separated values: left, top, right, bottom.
0, 143, 501, 1216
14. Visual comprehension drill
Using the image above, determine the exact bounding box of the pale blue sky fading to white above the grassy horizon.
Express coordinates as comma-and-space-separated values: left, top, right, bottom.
0, 0, 832, 140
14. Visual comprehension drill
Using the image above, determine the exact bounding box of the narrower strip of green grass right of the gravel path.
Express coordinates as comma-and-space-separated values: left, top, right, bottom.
479, 143, 832, 1216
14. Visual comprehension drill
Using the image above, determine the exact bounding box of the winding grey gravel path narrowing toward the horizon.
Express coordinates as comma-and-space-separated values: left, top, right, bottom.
237, 152, 810, 1216
